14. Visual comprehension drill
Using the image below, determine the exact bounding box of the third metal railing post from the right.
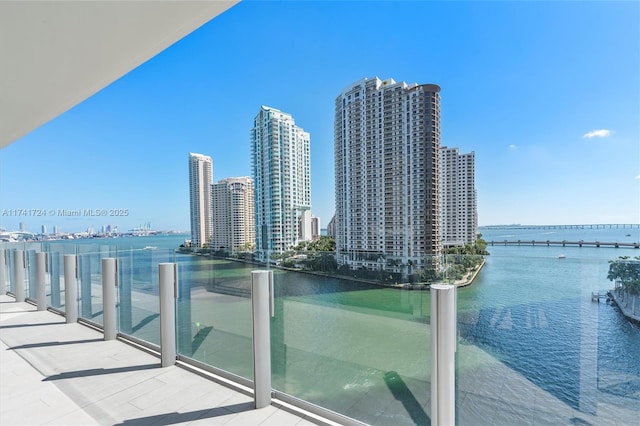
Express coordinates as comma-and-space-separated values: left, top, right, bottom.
158, 263, 178, 367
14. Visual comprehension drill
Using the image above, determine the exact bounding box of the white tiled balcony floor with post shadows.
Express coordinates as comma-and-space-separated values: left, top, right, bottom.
0, 295, 331, 425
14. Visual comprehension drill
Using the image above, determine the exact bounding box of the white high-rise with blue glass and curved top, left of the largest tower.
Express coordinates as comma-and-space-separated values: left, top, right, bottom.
251, 106, 311, 260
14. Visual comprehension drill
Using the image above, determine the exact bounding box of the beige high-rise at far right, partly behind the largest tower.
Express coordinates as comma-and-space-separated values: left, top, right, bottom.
440, 146, 478, 247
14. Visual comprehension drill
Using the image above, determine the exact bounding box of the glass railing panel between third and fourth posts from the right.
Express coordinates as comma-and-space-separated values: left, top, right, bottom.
117, 249, 175, 345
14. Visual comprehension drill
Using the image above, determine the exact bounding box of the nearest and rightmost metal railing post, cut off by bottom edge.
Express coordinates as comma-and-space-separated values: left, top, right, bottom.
431, 284, 456, 426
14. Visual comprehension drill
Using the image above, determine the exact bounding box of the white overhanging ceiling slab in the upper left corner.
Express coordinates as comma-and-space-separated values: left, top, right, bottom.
0, 0, 239, 148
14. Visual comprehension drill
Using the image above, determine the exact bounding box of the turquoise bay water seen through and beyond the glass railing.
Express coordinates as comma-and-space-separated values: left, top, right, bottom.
2, 229, 640, 425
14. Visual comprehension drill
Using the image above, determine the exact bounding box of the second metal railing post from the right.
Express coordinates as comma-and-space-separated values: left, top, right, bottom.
251, 271, 273, 408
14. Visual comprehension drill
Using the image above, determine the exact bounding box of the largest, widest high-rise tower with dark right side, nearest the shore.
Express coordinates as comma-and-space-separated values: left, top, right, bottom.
334, 78, 442, 275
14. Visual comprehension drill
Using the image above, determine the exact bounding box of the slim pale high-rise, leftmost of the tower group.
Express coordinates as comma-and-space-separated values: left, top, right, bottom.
189, 153, 213, 247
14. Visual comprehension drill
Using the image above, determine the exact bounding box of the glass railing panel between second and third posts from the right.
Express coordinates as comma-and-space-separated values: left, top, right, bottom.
176, 254, 256, 379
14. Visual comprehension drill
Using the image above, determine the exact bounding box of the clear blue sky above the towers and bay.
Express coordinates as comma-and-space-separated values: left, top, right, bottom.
0, 1, 640, 231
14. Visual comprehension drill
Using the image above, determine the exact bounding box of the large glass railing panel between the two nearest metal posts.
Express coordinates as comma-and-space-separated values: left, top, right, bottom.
271, 253, 430, 424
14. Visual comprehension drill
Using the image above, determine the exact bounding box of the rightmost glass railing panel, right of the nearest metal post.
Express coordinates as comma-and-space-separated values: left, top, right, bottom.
456, 241, 640, 425
